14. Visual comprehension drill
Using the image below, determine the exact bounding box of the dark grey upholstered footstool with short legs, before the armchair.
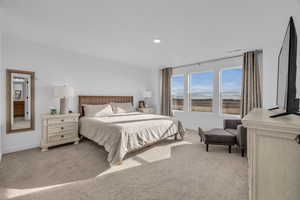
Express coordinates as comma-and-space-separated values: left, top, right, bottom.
199, 128, 236, 153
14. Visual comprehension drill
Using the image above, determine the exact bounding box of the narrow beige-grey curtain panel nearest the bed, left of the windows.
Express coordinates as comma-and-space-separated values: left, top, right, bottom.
161, 68, 172, 116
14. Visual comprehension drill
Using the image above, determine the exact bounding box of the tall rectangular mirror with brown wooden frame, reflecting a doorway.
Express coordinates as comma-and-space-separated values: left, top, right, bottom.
6, 69, 35, 133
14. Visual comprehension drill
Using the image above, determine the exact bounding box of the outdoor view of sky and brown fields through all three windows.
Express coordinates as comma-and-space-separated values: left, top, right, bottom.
171, 67, 243, 115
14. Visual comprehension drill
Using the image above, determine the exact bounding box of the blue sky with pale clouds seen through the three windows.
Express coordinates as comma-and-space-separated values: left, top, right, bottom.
172, 68, 243, 97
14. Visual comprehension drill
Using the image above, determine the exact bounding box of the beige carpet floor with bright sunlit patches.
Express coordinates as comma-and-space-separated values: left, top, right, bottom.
0, 131, 248, 200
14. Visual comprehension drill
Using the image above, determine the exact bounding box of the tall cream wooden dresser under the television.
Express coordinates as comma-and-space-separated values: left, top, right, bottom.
243, 109, 300, 200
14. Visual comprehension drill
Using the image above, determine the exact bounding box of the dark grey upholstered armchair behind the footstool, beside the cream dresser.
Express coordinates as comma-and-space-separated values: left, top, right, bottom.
223, 119, 247, 157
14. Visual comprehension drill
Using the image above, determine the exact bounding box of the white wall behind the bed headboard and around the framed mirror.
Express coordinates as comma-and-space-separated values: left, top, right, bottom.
1, 34, 152, 153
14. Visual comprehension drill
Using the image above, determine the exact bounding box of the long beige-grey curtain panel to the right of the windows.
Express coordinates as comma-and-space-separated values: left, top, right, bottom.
241, 51, 262, 117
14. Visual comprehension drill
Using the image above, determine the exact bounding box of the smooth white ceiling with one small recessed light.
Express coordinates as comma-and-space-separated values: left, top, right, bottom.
0, 0, 300, 67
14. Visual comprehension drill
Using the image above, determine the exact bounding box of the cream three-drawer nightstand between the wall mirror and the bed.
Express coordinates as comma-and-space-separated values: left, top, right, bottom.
41, 113, 79, 151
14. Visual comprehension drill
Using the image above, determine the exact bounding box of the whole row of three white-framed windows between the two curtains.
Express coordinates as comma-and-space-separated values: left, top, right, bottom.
171, 56, 243, 117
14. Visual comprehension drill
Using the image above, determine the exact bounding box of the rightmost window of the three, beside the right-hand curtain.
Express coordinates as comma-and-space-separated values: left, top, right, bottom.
220, 68, 243, 115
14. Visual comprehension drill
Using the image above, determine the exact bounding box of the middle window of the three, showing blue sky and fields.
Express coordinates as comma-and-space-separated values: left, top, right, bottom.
190, 72, 214, 112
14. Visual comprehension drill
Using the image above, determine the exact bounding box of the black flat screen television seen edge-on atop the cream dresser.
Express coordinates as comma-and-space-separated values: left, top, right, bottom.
271, 17, 299, 117
